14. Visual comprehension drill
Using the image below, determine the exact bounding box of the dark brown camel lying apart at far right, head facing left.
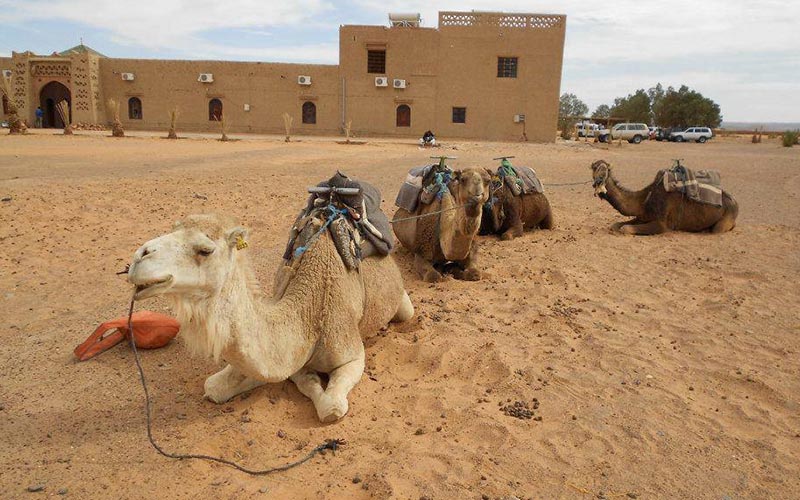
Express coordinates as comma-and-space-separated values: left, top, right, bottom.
591, 160, 739, 235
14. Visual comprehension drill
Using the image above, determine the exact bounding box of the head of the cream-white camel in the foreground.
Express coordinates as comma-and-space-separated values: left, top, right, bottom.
128, 214, 247, 300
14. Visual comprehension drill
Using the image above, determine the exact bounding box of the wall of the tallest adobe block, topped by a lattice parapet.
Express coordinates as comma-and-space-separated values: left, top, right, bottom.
436, 12, 566, 142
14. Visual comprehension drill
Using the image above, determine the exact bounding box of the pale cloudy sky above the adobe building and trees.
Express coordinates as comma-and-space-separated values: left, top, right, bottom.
0, 0, 800, 122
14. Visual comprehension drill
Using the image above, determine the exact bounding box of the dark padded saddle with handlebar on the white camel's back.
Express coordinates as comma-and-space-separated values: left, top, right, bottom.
283, 172, 394, 270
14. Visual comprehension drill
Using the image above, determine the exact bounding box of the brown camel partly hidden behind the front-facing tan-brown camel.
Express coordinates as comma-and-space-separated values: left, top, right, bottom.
481, 169, 553, 240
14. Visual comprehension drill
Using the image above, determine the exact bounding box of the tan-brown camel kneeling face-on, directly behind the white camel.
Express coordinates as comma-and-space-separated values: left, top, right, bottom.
392, 168, 491, 283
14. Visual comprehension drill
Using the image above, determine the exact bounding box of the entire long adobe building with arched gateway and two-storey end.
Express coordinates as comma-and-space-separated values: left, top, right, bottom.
0, 12, 566, 142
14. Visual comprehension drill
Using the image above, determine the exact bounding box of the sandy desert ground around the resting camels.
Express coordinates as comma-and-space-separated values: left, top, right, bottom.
0, 134, 800, 499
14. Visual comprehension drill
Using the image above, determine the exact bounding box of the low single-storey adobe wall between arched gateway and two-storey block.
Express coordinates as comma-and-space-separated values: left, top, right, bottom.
100, 59, 341, 134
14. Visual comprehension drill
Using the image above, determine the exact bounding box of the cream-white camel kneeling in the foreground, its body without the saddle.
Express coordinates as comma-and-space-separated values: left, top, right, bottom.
128, 214, 414, 423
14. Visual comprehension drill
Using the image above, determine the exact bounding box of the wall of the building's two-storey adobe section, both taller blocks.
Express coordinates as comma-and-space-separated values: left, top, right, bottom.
339, 12, 566, 142
